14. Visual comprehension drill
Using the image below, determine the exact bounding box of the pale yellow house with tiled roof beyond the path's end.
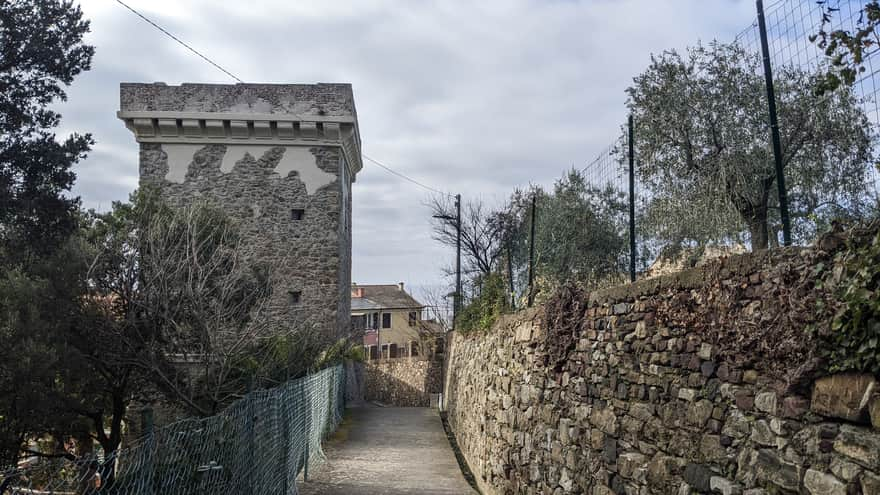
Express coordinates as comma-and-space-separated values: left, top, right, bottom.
351, 282, 443, 359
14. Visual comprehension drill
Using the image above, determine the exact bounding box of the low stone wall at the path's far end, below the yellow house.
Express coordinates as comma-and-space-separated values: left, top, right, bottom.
364, 358, 443, 407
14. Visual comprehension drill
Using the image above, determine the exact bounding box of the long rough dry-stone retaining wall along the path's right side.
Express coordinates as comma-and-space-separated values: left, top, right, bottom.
444, 249, 880, 495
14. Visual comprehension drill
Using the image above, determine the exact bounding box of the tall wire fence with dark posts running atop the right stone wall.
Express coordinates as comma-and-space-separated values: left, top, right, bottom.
496, 0, 880, 305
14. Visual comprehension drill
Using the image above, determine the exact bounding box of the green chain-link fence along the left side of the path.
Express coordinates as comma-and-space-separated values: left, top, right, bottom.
0, 365, 345, 495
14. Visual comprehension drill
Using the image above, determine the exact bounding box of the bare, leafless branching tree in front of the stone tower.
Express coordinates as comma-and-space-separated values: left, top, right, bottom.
89, 193, 289, 415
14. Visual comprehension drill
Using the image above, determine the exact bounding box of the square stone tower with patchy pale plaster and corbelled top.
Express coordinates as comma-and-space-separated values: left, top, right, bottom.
118, 83, 362, 340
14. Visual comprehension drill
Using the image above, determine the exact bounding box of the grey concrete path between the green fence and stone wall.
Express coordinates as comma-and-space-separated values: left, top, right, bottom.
300, 405, 476, 495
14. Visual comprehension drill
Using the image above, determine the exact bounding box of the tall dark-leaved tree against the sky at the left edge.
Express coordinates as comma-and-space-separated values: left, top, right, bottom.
0, 0, 95, 261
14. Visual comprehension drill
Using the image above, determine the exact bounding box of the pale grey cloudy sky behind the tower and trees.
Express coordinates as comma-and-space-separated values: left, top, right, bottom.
61, 0, 768, 302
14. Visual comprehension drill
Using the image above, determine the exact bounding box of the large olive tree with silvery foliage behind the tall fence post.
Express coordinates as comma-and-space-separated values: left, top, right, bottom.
621, 42, 874, 249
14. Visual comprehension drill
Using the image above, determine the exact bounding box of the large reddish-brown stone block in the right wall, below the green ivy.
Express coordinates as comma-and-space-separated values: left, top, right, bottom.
810, 373, 877, 422
